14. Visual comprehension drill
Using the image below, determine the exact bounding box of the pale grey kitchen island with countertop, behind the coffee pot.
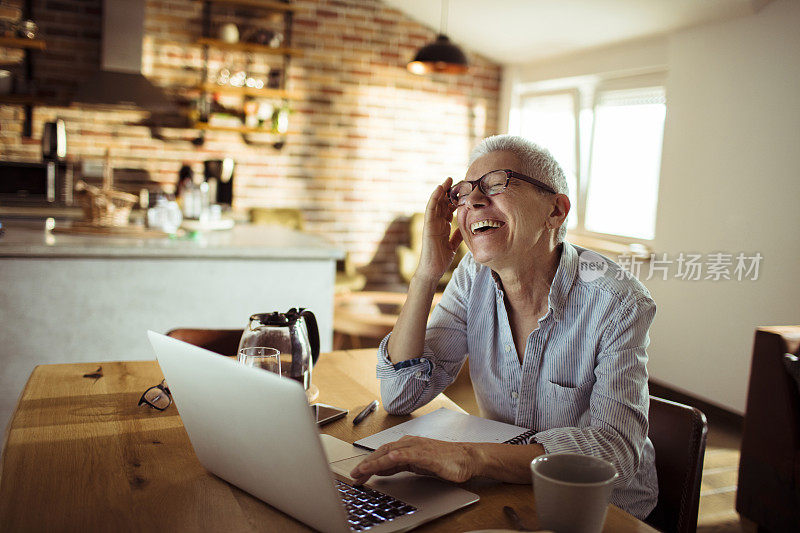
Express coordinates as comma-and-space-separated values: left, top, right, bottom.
0, 222, 344, 440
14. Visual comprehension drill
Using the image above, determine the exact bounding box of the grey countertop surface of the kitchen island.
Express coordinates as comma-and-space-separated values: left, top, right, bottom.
0, 222, 344, 260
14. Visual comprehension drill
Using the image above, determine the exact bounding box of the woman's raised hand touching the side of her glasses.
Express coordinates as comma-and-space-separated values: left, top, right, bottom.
414, 178, 461, 283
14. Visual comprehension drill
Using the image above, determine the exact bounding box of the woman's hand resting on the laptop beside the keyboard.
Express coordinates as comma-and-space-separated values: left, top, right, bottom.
350, 436, 477, 485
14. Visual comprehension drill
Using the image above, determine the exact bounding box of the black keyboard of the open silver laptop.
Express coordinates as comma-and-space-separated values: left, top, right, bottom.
336, 480, 417, 531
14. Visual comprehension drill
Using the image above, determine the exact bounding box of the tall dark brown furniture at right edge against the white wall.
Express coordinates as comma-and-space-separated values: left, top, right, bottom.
736, 326, 800, 531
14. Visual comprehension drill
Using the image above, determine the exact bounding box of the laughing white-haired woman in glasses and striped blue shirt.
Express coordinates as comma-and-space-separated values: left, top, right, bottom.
351, 135, 658, 519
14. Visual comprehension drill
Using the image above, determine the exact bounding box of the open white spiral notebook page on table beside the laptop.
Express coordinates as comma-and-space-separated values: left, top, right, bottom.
353, 407, 534, 450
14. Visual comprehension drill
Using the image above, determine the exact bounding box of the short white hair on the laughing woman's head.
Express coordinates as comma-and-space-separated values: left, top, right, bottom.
469, 135, 569, 243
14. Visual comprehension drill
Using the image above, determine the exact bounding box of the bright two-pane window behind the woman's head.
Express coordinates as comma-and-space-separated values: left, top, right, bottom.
509, 77, 666, 241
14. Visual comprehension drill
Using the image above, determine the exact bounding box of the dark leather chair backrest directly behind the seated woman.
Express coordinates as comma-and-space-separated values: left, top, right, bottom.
647, 396, 708, 533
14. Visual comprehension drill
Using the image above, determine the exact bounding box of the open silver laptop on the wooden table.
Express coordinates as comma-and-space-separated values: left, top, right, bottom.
148, 331, 479, 533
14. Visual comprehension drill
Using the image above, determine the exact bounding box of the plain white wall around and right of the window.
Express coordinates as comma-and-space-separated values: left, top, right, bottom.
505, 0, 800, 413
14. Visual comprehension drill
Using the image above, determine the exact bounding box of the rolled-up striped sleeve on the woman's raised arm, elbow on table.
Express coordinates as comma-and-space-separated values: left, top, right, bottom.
377, 254, 475, 415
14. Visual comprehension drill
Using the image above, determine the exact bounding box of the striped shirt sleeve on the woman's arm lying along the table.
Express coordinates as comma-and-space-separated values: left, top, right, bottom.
533, 295, 656, 487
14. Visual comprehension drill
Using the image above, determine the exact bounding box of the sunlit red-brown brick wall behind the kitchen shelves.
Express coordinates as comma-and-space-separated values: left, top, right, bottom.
0, 0, 500, 285
